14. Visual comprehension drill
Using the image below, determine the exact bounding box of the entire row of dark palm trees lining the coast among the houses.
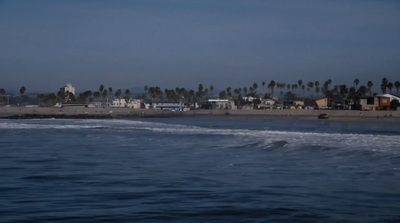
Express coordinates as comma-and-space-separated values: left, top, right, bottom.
6, 78, 400, 107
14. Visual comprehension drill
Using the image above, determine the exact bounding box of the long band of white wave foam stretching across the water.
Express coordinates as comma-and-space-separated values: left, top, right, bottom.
0, 119, 400, 150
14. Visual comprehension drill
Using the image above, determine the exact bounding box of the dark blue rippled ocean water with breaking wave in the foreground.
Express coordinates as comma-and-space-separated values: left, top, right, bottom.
0, 118, 400, 222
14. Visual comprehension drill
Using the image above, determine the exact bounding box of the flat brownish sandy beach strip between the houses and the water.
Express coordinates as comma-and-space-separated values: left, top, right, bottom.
0, 107, 400, 123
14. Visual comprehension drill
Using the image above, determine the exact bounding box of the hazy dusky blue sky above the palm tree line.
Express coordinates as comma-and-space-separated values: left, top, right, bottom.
0, 0, 400, 92
